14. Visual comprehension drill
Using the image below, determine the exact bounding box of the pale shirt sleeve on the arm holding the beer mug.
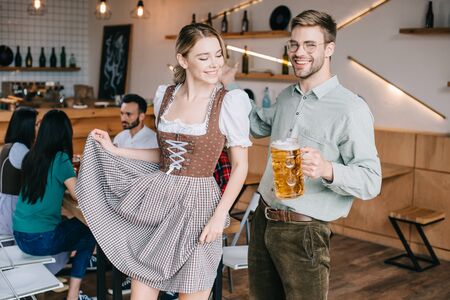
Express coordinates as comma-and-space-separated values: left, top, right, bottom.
323, 107, 382, 200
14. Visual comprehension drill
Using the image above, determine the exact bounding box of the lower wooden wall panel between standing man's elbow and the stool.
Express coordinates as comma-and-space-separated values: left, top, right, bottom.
344, 173, 414, 238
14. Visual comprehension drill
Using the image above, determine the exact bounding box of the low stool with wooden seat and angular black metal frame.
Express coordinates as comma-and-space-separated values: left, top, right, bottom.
384, 206, 445, 272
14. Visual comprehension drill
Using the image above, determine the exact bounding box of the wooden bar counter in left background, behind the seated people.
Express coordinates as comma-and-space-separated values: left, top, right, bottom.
0, 106, 155, 154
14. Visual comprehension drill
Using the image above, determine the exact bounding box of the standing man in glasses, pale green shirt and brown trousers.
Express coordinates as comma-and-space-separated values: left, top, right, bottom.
248, 10, 381, 300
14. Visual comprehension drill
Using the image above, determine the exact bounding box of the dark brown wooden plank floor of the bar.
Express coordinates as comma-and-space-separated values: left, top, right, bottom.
38, 235, 450, 300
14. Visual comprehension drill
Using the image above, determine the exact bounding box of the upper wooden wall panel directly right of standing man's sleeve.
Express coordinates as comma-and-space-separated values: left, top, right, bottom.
375, 130, 415, 167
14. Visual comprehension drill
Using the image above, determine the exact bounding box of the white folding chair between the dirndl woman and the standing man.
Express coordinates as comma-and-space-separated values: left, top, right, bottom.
223, 192, 260, 292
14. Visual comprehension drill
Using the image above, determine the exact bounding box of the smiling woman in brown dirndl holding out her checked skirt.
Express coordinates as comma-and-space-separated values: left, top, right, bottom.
76, 24, 251, 299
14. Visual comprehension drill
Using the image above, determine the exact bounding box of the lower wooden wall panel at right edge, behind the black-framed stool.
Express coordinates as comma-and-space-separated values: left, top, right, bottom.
411, 169, 450, 250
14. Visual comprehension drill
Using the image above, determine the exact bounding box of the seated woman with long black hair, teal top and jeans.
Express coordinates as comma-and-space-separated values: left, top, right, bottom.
13, 110, 95, 300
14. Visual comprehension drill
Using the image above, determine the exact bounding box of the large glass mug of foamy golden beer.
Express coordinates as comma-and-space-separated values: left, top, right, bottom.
270, 138, 304, 199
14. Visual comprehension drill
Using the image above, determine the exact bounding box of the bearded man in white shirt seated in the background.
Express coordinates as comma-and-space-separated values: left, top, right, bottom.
113, 94, 158, 149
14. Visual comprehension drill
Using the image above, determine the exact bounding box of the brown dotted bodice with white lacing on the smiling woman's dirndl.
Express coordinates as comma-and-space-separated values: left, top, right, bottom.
157, 85, 226, 177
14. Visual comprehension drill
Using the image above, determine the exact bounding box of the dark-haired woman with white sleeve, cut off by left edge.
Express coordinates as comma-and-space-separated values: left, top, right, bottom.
0, 107, 37, 236
